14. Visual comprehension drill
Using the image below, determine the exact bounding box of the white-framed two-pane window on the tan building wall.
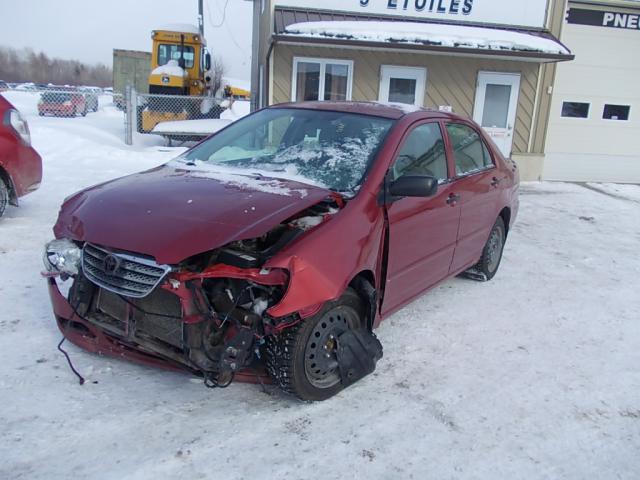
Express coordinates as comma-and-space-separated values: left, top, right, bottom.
291, 57, 353, 102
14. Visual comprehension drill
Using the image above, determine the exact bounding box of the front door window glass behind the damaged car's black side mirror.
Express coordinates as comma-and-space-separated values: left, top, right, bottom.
391, 123, 447, 180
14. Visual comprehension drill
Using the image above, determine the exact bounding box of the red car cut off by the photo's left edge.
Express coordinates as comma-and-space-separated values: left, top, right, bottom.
0, 95, 42, 217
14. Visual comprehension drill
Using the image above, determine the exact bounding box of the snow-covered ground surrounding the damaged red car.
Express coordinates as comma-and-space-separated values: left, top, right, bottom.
0, 93, 640, 480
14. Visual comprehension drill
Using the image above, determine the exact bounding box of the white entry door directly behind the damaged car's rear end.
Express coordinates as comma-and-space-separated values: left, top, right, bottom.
473, 72, 520, 157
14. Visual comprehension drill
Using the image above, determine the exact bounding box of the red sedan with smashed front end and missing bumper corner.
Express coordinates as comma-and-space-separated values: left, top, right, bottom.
45, 102, 518, 400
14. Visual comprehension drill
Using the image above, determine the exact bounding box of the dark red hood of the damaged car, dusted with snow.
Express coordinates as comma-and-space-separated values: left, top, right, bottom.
54, 165, 332, 264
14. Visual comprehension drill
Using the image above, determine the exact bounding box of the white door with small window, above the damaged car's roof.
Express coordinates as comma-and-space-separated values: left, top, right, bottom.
379, 65, 427, 107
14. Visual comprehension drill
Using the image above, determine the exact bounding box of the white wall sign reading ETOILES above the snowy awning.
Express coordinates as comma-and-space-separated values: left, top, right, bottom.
274, 0, 547, 28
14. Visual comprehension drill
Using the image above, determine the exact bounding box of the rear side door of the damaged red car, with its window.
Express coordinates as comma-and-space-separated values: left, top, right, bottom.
446, 123, 502, 273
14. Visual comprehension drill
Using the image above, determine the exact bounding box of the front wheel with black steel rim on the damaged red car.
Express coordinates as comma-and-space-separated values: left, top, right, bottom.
266, 288, 365, 401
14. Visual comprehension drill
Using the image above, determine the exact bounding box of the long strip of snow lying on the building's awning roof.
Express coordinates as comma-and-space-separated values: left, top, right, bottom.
285, 21, 571, 55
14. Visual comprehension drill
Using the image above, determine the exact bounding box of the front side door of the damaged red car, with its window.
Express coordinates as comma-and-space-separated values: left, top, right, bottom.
382, 122, 460, 315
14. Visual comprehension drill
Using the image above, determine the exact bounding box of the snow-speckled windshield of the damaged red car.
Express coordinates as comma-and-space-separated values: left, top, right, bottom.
180, 108, 393, 194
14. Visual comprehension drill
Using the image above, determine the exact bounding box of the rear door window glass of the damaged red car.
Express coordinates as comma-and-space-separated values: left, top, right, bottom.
447, 123, 493, 176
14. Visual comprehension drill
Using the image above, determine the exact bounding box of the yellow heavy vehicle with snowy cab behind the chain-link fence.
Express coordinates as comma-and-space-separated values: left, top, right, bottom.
138, 25, 223, 133
